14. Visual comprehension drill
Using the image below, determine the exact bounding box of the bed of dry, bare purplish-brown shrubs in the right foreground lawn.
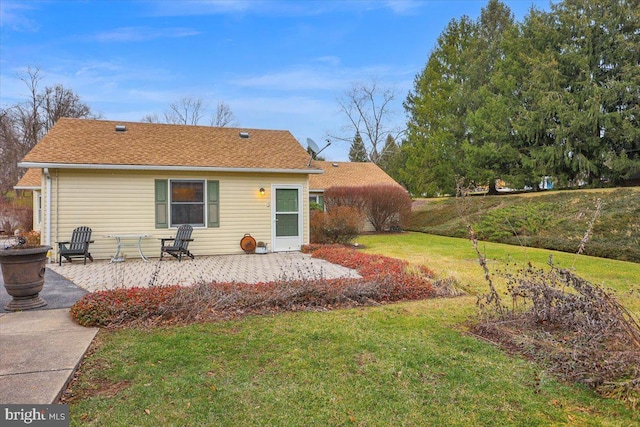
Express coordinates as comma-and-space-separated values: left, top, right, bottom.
475, 260, 640, 408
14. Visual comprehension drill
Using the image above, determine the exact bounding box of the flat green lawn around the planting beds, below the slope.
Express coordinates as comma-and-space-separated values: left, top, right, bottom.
71, 233, 640, 426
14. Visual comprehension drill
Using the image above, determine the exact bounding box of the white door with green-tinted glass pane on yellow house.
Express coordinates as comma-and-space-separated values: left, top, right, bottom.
271, 185, 303, 252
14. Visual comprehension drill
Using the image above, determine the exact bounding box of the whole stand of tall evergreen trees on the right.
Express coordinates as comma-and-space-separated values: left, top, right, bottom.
400, 0, 640, 194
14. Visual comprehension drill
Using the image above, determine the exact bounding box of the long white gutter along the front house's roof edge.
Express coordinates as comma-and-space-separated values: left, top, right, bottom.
18, 162, 324, 174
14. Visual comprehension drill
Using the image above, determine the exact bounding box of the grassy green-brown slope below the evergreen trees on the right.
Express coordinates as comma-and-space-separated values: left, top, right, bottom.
408, 187, 640, 262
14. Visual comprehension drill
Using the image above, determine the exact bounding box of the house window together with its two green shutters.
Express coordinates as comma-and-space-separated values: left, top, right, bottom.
155, 179, 220, 228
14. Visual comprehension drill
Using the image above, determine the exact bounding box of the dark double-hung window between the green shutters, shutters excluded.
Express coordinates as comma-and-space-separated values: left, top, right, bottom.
169, 181, 205, 227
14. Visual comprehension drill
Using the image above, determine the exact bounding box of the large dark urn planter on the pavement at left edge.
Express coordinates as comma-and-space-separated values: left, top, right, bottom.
0, 246, 51, 311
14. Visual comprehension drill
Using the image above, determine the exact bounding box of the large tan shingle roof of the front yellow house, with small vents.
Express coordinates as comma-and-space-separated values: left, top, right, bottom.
20, 118, 321, 173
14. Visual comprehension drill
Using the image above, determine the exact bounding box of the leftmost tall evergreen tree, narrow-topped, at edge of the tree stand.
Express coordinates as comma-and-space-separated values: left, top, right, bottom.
400, 16, 476, 195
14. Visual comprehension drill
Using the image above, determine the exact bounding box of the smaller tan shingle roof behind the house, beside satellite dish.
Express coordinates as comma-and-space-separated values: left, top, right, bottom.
309, 160, 402, 191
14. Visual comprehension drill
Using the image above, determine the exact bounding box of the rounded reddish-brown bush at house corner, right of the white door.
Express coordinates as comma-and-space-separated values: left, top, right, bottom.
309, 206, 364, 244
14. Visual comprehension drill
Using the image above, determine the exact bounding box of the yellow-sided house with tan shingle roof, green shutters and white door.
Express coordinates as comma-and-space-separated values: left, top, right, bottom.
19, 118, 322, 259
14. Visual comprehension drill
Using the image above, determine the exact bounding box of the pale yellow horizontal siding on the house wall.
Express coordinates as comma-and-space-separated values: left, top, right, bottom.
43, 169, 309, 259
